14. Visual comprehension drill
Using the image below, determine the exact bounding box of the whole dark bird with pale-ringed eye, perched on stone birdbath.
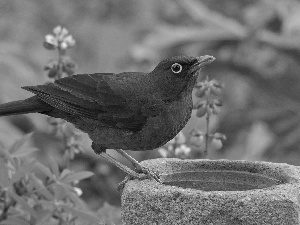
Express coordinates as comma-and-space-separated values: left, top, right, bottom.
0, 55, 215, 180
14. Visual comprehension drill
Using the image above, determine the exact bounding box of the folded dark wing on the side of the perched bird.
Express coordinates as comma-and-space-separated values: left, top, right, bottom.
23, 73, 146, 130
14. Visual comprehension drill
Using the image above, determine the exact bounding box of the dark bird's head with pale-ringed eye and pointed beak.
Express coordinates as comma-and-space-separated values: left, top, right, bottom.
150, 55, 215, 97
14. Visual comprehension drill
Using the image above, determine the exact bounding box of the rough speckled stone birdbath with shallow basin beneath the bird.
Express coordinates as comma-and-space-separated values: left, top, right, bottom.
122, 159, 300, 225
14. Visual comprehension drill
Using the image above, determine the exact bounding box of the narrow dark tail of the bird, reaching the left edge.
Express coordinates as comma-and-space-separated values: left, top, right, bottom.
0, 96, 52, 117
